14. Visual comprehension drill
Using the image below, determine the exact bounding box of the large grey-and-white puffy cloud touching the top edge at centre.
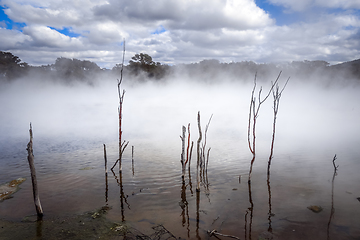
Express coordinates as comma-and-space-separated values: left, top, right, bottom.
94, 0, 273, 31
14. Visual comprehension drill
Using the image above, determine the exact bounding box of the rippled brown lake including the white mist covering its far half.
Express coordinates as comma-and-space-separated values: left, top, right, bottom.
0, 76, 360, 239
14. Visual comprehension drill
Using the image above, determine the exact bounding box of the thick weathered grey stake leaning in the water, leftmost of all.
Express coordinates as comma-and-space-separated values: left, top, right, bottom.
26, 123, 44, 219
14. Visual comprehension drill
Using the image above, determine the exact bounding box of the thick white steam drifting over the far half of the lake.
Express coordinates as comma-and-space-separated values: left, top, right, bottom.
0, 77, 360, 158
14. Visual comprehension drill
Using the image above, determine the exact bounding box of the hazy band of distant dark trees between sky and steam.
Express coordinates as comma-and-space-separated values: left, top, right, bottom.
0, 51, 360, 83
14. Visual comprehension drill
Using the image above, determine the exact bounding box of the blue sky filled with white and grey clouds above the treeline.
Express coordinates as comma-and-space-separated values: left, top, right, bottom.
0, 0, 360, 68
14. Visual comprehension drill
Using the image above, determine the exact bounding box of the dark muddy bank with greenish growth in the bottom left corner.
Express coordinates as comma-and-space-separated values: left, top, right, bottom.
0, 206, 178, 240
